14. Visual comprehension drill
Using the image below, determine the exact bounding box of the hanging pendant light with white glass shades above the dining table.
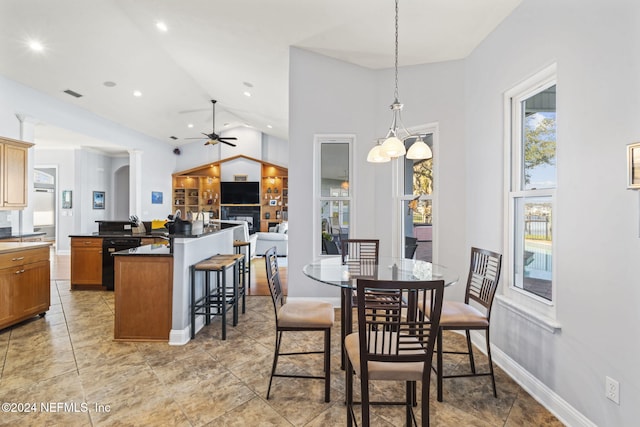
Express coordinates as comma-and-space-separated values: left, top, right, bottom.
367, 0, 433, 163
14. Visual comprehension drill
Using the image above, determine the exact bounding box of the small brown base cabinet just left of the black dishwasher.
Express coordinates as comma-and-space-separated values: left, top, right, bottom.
71, 237, 102, 289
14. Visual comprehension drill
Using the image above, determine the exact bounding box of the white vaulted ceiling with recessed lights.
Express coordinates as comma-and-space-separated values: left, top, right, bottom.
0, 0, 521, 151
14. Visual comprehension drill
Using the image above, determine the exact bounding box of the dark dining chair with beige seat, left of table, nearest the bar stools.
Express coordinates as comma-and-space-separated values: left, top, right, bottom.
264, 246, 335, 402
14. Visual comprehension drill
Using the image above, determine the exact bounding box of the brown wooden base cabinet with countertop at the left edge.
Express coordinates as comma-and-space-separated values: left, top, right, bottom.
0, 243, 51, 329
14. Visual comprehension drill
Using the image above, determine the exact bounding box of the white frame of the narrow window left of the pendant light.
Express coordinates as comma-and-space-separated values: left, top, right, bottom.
312, 134, 356, 259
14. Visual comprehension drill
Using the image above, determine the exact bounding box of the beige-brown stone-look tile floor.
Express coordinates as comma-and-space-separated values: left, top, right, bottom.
0, 260, 562, 427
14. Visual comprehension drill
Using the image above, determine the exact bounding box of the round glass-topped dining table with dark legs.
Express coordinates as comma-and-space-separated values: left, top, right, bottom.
302, 257, 458, 369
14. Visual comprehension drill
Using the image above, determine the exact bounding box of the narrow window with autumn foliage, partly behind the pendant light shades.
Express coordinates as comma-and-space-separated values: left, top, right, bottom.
400, 129, 434, 261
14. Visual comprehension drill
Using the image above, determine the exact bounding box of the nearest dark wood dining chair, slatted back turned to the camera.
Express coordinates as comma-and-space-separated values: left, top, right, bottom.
344, 279, 444, 427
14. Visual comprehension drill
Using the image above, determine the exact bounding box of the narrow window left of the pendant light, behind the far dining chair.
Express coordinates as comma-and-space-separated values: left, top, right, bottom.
316, 137, 353, 255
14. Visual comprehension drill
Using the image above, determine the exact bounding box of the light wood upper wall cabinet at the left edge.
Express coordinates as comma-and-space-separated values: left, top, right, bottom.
0, 137, 33, 209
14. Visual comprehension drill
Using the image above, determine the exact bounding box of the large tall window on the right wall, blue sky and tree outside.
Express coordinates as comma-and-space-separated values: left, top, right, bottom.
505, 66, 557, 314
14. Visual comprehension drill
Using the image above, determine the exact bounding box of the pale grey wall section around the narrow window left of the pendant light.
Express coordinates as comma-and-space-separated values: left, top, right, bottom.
287, 48, 376, 298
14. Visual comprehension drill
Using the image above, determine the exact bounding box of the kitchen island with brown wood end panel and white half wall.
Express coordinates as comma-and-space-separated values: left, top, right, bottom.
113, 223, 238, 345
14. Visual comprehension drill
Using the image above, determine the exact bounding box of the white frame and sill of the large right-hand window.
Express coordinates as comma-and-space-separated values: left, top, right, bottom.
499, 64, 558, 322
